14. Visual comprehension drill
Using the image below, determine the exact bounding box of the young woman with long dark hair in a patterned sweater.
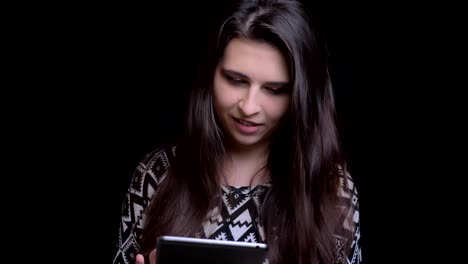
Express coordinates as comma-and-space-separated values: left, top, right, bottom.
114, 0, 361, 263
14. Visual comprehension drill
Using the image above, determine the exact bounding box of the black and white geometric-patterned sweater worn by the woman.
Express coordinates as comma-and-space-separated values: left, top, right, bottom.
113, 146, 362, 264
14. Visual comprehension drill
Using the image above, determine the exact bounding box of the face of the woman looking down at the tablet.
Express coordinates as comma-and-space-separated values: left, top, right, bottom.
213, 38, 291, 150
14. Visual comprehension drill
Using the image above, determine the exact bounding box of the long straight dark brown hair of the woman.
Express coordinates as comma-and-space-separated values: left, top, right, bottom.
142, 0, 351, 263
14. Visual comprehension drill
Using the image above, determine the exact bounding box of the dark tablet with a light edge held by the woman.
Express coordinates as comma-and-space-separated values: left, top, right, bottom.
156, 236, 268, 264
